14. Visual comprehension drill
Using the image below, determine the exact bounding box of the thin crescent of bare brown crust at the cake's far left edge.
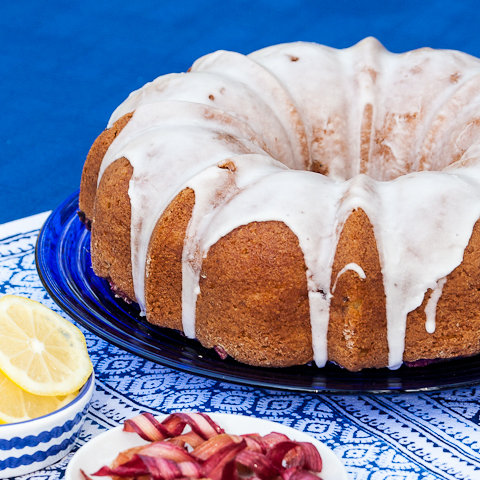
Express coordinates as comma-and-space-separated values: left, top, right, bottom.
79, 113, 133, 221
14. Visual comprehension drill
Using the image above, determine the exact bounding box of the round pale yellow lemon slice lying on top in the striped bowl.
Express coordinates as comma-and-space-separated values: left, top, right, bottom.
0, 295, 92, 396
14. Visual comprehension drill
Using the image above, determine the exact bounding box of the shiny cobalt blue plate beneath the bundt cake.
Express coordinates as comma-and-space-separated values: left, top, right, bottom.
36, 193, 480, 393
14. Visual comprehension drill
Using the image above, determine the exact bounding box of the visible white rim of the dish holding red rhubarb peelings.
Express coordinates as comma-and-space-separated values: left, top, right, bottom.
65, 413, 348, 480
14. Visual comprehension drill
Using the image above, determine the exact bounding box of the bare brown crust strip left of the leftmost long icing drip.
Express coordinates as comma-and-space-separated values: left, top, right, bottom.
91, 157, 135, 300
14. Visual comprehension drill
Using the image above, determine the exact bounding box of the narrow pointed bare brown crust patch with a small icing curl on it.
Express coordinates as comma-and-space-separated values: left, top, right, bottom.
328, 209, 388, 371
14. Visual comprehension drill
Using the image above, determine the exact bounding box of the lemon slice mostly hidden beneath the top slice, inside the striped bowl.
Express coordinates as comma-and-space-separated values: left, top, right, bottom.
0, 372, 78, 423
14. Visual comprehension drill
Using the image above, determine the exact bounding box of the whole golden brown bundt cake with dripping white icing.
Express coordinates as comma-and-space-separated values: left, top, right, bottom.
79, 38, 480, 371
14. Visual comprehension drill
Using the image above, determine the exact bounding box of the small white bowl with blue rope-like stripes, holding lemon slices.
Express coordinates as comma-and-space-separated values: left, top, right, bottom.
0, 372, 95, 478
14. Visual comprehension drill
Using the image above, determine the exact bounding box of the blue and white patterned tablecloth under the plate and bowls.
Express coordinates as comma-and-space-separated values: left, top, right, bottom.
0, 214, 480, 480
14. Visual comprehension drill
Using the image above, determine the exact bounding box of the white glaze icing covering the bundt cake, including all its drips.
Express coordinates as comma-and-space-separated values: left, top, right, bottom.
100, 39, 480, 368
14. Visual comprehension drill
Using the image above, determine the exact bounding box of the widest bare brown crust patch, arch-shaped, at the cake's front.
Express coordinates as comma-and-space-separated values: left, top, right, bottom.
196, 221, 313, 367
